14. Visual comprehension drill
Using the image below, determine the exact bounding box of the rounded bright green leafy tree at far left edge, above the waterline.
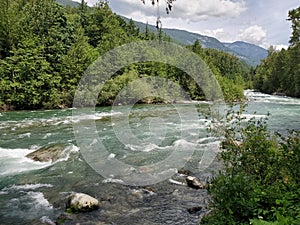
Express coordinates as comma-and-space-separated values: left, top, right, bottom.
0, 37, 54, 109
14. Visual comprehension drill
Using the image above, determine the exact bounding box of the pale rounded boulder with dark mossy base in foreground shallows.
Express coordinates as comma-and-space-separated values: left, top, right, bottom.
67, 193, 99, 212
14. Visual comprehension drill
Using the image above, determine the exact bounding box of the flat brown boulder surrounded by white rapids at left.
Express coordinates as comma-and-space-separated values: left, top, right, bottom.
26, 144, 67, 162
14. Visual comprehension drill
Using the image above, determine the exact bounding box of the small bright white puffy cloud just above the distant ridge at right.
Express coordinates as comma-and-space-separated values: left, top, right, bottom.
238, 25, 267, 47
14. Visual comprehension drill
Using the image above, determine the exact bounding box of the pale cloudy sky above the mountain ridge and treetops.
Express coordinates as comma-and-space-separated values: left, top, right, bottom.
76, 0, 300, 49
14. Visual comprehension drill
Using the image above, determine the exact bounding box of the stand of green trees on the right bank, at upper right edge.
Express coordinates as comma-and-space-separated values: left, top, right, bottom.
254, 7, 300, 97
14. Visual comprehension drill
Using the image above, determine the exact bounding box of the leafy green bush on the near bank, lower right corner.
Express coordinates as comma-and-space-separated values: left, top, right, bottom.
201, 106, 300, 225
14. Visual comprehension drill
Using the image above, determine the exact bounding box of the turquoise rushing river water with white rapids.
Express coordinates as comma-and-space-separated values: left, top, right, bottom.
0, 91, 300, 224
